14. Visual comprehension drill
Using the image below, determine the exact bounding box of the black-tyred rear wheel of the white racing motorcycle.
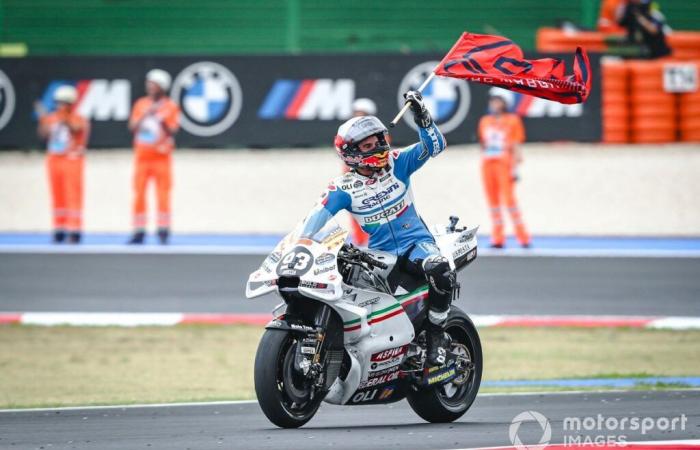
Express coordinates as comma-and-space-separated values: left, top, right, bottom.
407, 306, 483, 423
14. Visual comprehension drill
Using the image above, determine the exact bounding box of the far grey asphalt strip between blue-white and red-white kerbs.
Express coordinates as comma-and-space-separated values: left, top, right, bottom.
0, 253, 700, 316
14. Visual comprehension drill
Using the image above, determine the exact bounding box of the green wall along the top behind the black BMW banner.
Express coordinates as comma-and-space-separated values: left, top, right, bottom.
0, 0, 700, 56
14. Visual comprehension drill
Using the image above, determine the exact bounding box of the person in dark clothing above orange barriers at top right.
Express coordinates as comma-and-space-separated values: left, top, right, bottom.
617, 0, 671, 59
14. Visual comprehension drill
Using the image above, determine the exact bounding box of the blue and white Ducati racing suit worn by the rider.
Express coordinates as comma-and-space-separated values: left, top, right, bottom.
303, 124, 457, 324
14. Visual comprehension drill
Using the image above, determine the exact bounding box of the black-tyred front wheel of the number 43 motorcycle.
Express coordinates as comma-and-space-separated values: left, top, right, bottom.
254, 330, 323, 428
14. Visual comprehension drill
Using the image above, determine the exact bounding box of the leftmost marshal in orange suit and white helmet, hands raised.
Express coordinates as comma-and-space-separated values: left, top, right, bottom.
37, 85, 90, 244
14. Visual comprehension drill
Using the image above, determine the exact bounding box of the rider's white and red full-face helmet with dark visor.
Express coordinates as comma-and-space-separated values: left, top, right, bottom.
334, 116, 390, 170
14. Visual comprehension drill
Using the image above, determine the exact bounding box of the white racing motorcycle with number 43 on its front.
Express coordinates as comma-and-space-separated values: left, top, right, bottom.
246, 217, 483, 428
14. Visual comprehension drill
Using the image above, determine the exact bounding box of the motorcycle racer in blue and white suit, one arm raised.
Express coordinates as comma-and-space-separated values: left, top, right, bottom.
303, 91, 459, 366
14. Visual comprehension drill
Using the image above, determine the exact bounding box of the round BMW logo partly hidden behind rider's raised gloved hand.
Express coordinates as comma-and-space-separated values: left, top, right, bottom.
398, 61, 471, 134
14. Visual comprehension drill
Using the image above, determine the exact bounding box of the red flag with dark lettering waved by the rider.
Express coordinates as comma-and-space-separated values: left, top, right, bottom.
435, 33, 591, 104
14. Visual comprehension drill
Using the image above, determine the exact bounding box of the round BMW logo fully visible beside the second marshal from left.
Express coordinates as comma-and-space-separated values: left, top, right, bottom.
172, 61, 243, 136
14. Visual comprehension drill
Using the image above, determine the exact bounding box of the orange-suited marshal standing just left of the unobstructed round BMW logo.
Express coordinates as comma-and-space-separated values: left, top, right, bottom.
129, 69, 180, 244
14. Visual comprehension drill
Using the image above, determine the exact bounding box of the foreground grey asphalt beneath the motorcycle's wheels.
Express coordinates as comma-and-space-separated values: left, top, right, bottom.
0, 391, 700, 450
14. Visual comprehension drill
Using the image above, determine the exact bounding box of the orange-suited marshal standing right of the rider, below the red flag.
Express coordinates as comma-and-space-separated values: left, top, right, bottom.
479, 88, 530, 248
